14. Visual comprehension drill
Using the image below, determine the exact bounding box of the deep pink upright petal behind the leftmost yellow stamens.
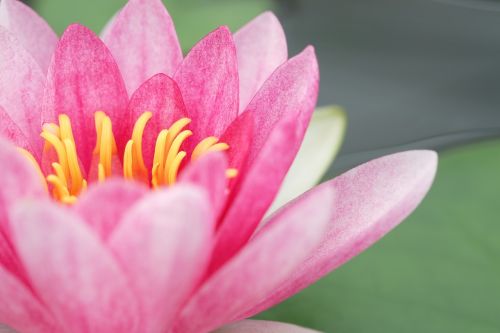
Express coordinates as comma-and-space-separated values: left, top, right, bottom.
44, 24, 128, 171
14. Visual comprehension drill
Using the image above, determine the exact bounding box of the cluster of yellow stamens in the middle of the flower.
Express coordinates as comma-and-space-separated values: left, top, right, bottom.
19, 111, 238, 204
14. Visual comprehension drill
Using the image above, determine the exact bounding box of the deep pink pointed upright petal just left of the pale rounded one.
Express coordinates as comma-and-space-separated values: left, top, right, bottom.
174, 27, 239, 142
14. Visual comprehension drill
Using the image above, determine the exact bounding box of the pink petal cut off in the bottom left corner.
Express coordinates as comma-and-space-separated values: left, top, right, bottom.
0, 266, 59, 333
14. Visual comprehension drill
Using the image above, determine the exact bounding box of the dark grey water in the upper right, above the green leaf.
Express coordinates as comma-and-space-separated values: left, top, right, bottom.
278, 0, 500, 172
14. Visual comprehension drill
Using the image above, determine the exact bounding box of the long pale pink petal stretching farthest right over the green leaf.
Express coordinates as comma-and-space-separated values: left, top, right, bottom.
238, 150, 437, 318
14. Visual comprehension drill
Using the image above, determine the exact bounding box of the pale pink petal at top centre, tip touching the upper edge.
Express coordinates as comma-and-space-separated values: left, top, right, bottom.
103, 0, 182, 94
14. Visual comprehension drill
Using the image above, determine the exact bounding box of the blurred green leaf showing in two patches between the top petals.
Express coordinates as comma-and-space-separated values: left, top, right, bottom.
32, 0, 273, 51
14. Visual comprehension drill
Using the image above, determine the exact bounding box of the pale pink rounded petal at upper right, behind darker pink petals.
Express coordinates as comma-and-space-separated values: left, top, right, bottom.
234, 12, 288, 112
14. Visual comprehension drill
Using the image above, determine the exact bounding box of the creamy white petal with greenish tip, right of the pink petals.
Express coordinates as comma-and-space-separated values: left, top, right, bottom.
269, 106, 347, 212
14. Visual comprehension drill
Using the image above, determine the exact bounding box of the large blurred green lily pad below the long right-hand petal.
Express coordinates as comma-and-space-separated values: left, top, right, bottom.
259, 141, 500, 333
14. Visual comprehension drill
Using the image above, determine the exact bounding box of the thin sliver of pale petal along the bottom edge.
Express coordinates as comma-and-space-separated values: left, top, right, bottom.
214, 320, 318, 333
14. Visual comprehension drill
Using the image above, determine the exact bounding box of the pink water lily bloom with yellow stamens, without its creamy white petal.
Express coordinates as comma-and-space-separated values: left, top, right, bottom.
0, 0, 437, 333
